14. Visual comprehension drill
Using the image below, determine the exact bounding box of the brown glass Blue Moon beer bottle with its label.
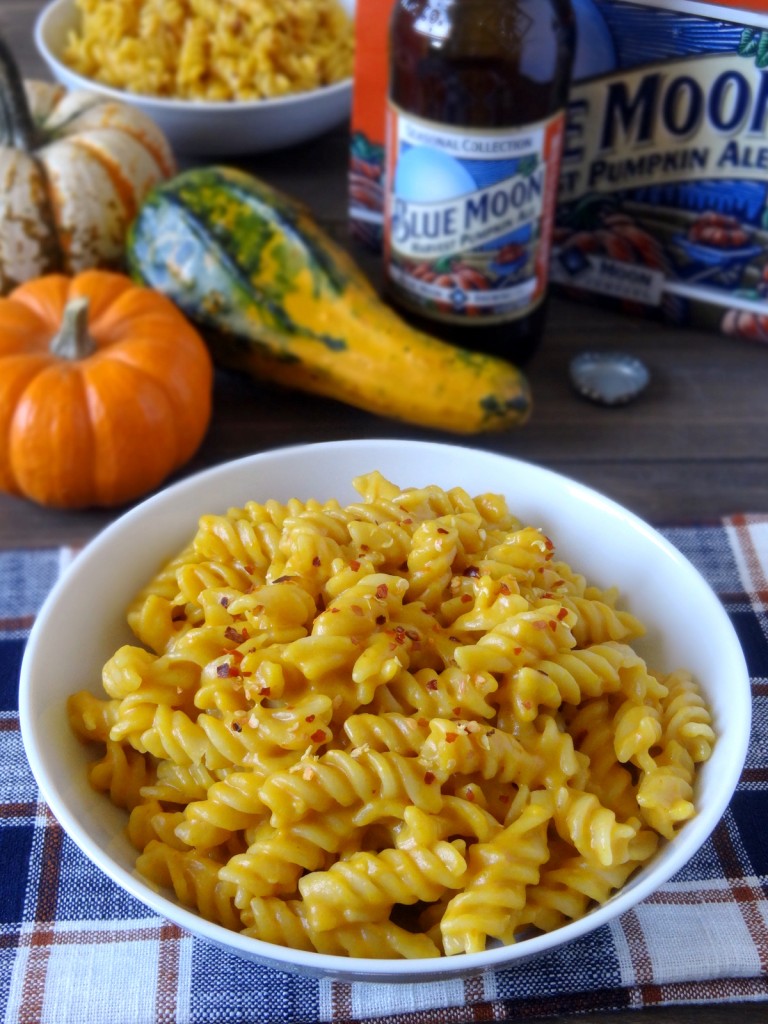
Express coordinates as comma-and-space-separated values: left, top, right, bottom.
384, 0, 575, 364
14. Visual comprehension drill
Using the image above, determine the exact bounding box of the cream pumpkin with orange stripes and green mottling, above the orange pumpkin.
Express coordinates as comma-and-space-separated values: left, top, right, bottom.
0, 39, 175, 295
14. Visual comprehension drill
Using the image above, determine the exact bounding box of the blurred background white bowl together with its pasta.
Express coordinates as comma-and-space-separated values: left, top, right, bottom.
35, 0, 355, 158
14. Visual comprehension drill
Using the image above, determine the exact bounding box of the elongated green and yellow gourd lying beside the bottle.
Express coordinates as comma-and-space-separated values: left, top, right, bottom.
127, 167, 530, 433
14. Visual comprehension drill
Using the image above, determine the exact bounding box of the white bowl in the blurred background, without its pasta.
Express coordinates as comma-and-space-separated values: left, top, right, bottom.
35, 0, 354, 157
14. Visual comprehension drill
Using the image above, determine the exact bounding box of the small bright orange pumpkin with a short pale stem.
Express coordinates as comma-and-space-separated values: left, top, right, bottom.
0, 270, 213, 509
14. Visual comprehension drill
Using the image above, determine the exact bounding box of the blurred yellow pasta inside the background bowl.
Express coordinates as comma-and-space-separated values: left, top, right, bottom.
63, 0, 354, 101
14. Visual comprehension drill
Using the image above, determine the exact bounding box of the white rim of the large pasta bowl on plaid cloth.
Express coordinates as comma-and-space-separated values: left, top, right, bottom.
19, 439, 752, 983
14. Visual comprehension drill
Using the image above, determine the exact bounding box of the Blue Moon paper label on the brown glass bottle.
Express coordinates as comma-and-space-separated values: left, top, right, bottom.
384, 102, 564, 323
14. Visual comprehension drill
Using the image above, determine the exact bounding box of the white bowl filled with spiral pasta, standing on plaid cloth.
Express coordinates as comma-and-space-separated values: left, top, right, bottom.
20, 440, 750, 982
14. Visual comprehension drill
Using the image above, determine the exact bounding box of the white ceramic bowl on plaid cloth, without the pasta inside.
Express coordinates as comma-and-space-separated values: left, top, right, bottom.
19, 440, 751, 982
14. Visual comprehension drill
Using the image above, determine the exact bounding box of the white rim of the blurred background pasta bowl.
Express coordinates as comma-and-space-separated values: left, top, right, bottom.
33, 0, 352, 115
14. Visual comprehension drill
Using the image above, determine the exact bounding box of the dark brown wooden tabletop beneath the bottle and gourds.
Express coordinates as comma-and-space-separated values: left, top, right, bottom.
6, 8, 768, 1024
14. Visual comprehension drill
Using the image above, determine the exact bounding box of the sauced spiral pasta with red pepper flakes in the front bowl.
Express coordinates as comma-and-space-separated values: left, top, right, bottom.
68, 472, 716, 958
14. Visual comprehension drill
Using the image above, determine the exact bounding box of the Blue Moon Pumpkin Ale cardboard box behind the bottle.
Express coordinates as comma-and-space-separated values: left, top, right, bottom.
349, 0, 768, 341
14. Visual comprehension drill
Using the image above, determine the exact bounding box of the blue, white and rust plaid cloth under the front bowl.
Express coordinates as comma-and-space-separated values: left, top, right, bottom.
0, 516, 768, 1024
